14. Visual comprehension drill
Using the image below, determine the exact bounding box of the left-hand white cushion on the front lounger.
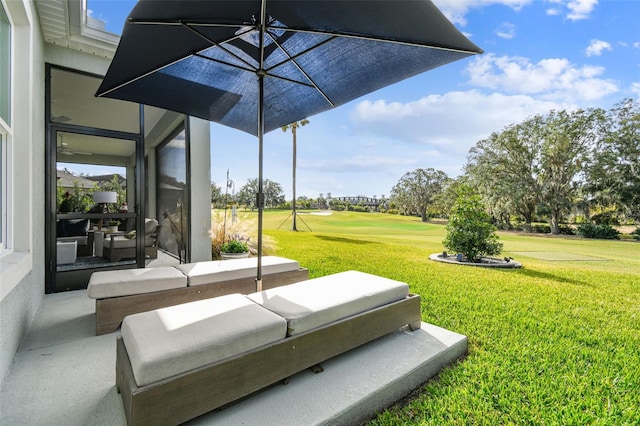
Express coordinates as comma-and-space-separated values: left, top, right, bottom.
122, 294, 287, 386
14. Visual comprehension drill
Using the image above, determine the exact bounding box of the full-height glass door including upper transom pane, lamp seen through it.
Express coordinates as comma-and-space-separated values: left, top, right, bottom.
45, 66, 145, 293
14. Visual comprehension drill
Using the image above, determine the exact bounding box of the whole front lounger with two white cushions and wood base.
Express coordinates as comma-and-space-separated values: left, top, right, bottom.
116, 271, 421, 425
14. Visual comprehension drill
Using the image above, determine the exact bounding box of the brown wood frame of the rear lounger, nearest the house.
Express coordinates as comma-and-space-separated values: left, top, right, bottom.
96, 268, 309, 336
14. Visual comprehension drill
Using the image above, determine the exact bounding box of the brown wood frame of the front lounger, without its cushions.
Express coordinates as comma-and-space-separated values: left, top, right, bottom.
116, 295, 421, 426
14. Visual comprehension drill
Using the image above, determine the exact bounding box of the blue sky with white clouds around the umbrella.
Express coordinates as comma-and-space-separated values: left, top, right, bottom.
89, 0, 640, 198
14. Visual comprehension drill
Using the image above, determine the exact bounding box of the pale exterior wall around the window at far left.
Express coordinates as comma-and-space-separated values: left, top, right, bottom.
0, 0, 45, 384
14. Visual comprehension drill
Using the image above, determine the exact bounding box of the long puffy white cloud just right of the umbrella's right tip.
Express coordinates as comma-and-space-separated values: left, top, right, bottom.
467, 54, 618, 102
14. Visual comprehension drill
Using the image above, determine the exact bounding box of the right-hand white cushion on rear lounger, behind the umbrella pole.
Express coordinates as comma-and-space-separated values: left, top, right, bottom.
176, 256, 300, 286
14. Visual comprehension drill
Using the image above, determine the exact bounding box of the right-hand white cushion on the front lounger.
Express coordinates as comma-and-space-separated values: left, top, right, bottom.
247, 271, 409, 336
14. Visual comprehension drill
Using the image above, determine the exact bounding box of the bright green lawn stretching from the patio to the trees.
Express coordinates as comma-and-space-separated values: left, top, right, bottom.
255, 212, 640, 425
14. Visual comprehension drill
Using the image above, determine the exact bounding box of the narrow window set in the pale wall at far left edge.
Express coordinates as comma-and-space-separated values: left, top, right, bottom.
0, 4, 12, 252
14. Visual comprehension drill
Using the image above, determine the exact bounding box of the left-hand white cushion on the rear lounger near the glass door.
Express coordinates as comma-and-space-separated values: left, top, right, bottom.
87, 266, 187, 299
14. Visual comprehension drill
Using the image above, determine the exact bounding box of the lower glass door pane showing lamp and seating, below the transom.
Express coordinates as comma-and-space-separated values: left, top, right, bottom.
51, 127, 138, 291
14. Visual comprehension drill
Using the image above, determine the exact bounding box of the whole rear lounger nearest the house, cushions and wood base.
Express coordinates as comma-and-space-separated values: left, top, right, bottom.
87, 256, 309, 335
